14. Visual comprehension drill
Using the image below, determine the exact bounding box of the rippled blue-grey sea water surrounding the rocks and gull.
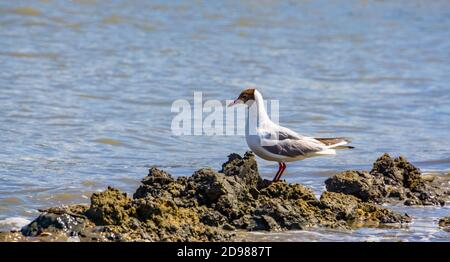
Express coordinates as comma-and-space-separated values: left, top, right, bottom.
0, 0, 450, 241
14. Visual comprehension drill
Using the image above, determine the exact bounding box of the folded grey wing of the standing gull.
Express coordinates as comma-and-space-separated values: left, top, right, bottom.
262, 139, 325, 157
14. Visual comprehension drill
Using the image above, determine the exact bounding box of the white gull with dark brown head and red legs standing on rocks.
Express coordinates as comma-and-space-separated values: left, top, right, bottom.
228, 89, 353, 182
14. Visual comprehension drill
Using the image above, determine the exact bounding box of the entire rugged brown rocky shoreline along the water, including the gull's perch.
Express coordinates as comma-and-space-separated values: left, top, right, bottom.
0, 152, 450, 241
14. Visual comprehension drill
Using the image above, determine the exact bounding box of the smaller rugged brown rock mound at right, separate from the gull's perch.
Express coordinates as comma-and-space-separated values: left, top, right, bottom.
325, 154, 449, 206
